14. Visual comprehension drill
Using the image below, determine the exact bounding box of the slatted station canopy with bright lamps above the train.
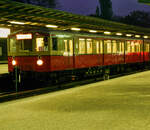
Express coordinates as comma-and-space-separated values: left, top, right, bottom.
0, 0, 150, 35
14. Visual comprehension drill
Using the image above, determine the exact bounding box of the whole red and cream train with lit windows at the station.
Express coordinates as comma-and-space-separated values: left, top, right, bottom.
7, 30, 150, 82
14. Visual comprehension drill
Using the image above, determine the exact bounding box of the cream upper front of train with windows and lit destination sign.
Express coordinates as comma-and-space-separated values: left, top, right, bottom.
9, 34, 48, 53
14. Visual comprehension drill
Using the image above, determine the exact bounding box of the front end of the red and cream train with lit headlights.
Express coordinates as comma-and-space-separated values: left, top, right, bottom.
8, 32, 50, 79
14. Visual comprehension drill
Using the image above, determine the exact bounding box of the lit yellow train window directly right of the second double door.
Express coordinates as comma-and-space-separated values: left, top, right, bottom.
104, 40, 112, 54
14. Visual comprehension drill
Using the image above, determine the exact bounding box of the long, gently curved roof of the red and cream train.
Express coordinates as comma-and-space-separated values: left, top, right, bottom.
9, 29, 146, 40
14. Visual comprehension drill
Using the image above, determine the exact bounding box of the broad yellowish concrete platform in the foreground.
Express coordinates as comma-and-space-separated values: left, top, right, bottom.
0, 71, 150, 130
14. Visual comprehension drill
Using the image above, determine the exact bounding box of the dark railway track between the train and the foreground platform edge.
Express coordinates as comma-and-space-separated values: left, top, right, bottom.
0, 69, 147, 102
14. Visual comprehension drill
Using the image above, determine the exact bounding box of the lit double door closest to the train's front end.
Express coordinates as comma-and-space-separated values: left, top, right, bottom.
63, 39, 73, 69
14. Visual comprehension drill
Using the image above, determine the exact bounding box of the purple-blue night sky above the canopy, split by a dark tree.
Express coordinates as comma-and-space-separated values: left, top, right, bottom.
58, 0, 150, 16
